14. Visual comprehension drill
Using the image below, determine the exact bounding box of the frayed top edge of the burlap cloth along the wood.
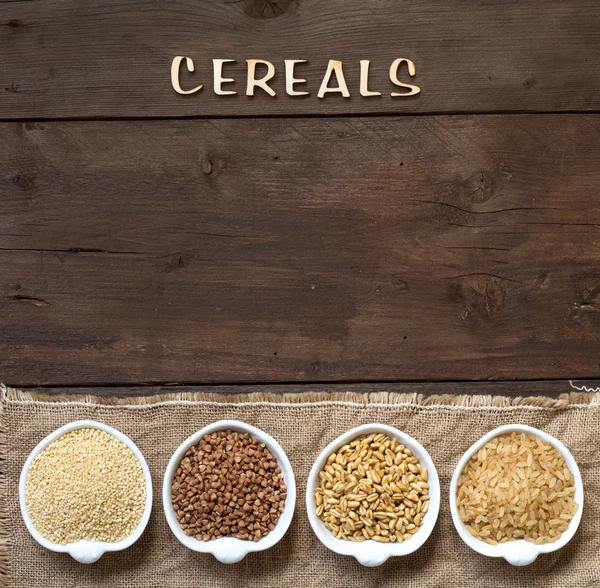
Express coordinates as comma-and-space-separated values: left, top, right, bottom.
0, 386, 600, 412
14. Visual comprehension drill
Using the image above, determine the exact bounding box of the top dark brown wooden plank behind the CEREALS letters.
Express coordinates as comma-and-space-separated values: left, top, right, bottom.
0, 0, 600, 119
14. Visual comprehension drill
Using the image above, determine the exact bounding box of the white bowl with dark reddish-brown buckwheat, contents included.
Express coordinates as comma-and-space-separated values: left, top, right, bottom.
163, 421, 296, 563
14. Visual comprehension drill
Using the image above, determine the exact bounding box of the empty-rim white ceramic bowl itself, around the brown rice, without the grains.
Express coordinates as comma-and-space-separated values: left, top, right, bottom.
450, 425, 583, 566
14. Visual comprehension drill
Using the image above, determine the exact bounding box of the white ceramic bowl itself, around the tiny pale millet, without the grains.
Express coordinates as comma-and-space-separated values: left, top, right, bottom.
19, 421, 152, 563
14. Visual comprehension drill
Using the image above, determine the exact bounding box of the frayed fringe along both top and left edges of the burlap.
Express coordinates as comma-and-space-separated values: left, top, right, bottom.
0, 385, 600, 588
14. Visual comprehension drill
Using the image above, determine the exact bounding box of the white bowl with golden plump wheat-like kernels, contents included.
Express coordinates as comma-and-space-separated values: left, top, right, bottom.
306, 424, 440, 567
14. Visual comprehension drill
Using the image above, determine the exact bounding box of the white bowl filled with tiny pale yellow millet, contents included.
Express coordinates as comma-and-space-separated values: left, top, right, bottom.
19, 420, 152, 563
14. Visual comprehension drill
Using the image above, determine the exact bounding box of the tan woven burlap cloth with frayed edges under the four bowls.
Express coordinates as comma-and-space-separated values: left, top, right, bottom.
0, 390, 600, 588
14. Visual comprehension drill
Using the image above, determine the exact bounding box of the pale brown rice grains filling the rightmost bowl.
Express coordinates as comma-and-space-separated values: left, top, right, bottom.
456, 433, 578, 545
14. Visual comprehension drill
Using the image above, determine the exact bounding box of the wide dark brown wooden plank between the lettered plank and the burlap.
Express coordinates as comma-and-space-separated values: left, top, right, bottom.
0, 114, 600, 385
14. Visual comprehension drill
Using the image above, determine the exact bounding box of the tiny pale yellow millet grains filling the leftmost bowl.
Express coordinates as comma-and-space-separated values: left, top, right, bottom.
25, 428, 146, 544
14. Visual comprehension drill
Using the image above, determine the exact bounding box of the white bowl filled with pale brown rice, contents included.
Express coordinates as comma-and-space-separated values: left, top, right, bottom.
450, 425, 583, 566
